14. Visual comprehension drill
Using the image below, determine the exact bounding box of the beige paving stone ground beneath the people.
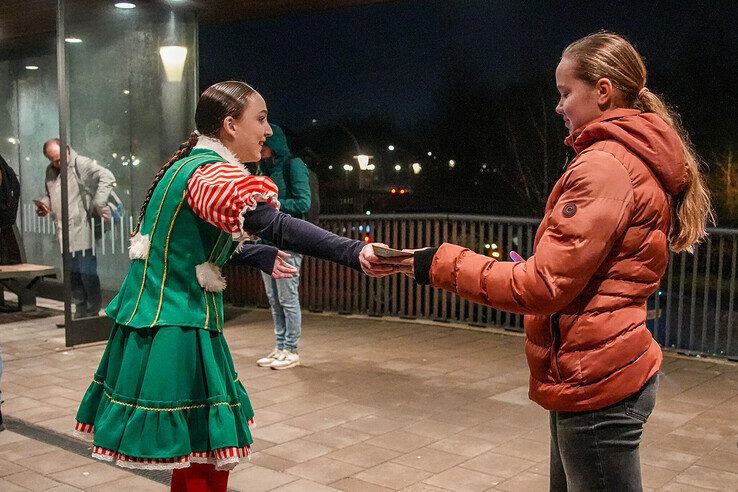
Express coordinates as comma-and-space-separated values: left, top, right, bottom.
0, 300, 738, 492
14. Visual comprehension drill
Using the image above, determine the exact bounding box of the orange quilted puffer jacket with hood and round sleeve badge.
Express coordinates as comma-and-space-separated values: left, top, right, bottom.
430, 109, 689, 411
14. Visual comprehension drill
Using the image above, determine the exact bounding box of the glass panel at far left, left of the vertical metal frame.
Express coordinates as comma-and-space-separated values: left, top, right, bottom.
0, 34, 62, 310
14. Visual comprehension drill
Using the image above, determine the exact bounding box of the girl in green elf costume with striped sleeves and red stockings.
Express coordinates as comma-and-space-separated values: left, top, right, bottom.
76, 81, 391, 491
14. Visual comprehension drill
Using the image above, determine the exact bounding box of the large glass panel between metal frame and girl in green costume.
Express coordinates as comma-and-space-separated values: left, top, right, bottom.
64, 0, 197, 332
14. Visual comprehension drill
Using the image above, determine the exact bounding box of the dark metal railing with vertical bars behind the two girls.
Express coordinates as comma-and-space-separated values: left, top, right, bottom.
226, 214, 738, 359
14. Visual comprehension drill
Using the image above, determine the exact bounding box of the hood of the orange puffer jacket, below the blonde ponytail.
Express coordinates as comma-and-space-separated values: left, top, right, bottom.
564, 109, 690, 195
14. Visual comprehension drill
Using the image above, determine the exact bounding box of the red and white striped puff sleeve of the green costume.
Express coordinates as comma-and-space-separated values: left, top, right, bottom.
187, 162, 279, 233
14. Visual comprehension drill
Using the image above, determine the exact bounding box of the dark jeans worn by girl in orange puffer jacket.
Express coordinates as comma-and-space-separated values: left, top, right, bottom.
550, 374, 659, 492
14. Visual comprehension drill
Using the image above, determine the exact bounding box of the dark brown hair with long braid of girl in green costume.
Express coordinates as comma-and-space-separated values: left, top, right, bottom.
131, 80, 256, 236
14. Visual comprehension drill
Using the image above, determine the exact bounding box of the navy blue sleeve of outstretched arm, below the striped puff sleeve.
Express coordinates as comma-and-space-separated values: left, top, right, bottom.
243, 203, 364, 271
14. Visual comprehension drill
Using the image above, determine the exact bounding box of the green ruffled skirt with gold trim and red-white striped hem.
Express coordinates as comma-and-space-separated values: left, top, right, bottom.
76, 324, 254, 469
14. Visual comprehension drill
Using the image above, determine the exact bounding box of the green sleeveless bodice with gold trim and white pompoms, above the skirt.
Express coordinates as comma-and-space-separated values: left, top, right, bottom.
105, 149, 237, 331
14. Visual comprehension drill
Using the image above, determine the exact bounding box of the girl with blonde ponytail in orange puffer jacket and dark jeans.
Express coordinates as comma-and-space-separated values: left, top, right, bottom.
376, 32, 712, 491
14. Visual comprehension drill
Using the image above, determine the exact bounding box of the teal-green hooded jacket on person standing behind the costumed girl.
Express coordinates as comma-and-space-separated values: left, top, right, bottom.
259, 125, 310, 218
